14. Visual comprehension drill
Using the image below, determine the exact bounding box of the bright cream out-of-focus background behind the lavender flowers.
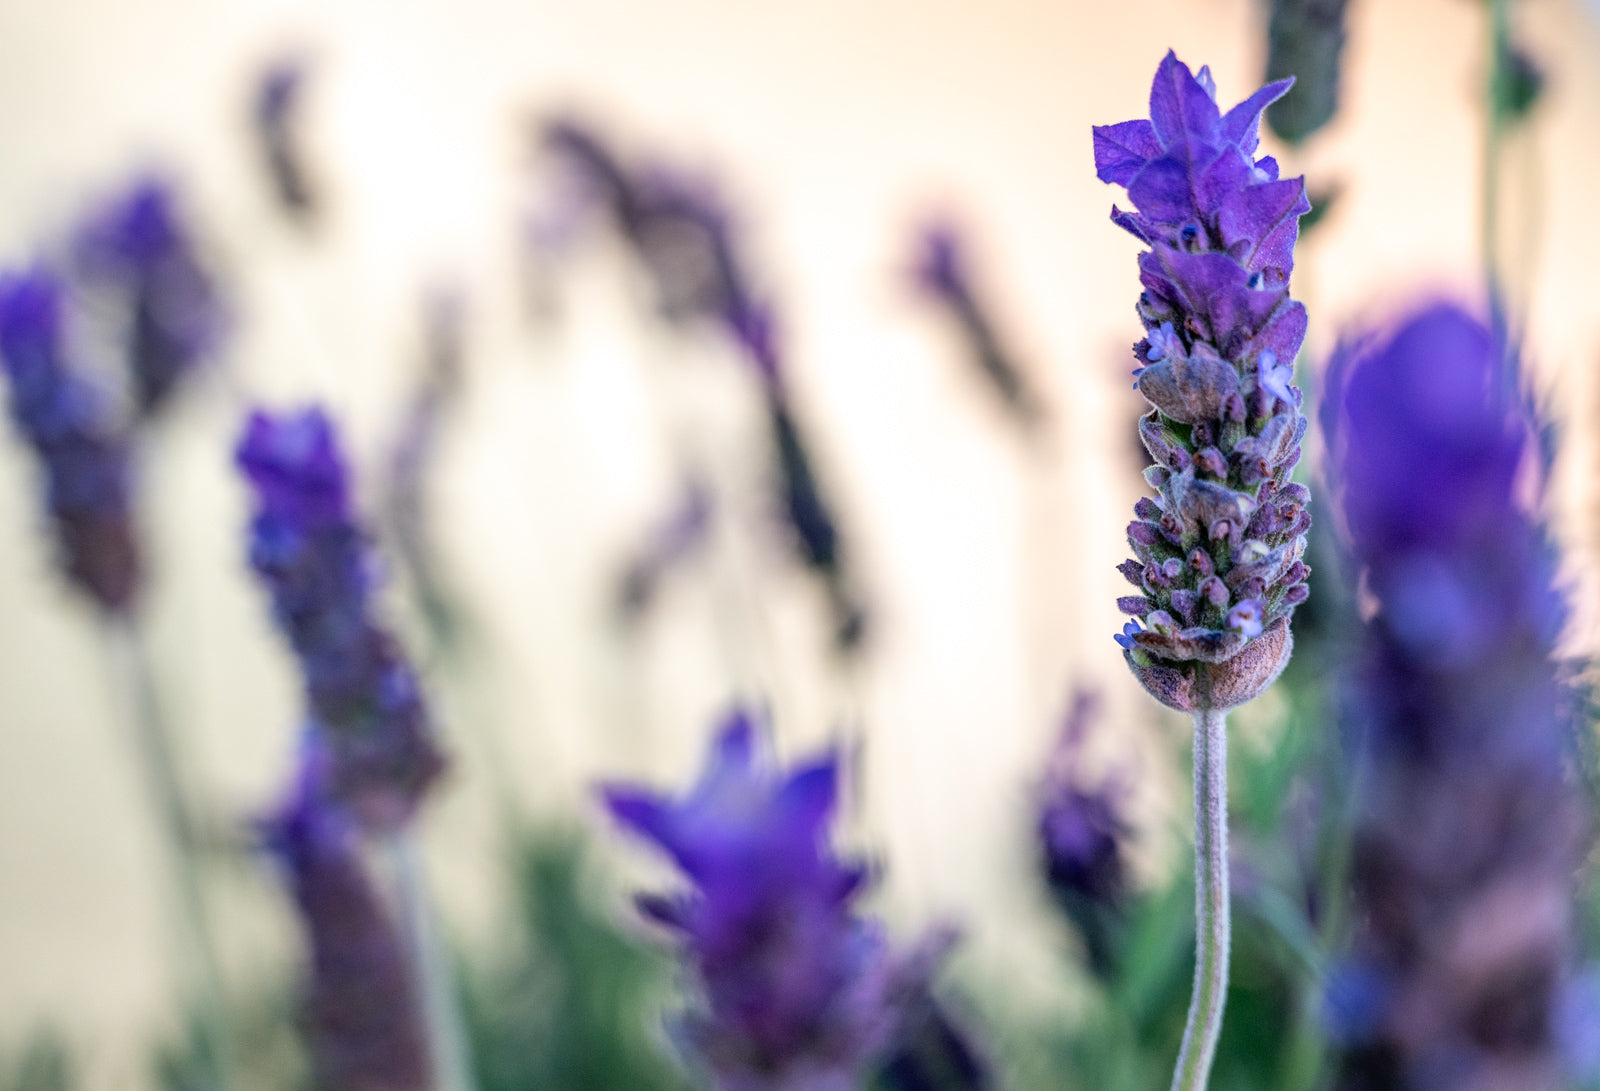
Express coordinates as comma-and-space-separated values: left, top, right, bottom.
0, 0, 1600, 1086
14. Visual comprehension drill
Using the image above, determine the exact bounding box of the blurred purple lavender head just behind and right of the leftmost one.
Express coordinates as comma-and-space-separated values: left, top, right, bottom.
75, 178, 227, 418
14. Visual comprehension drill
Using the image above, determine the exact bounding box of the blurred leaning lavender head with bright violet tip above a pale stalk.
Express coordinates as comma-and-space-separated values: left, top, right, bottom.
235, 408, 443, 830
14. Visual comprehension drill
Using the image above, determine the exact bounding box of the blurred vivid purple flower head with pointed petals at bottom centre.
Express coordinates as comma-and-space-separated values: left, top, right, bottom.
603, 712, 894, 1091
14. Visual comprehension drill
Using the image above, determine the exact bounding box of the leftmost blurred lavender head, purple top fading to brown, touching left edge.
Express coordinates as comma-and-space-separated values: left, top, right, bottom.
0, 267, 139, 614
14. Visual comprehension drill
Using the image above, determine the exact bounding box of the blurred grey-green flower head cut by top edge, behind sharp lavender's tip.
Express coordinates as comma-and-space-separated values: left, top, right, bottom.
1267, 0, 1350, 144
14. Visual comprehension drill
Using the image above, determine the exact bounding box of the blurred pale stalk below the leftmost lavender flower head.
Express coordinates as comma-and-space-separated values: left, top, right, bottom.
104, 617, 232, 1091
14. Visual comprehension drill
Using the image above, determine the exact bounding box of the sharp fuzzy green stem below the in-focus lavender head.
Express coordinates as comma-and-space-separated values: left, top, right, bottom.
1173, 709, 1230, 1091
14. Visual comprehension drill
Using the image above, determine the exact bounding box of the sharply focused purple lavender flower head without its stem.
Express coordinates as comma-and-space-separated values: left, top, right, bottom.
1094, 53, 1310, 710
